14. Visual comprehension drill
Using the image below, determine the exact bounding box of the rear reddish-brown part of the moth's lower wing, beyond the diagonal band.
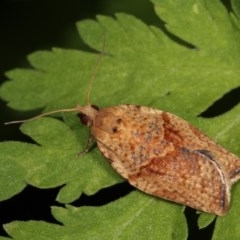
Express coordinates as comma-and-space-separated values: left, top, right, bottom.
129, 146, 229, 215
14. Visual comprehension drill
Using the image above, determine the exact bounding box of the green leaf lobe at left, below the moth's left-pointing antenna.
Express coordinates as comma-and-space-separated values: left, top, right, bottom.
0, 118, 120, 203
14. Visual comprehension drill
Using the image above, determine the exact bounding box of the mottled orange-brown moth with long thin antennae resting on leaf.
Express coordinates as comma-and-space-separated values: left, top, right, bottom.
7, 36, 240, 215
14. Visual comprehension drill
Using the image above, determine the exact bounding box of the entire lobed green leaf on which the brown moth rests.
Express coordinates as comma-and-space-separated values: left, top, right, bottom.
0, 0, 240, 239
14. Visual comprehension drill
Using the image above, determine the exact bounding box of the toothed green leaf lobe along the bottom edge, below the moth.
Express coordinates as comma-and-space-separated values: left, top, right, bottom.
4, 191, 186, 240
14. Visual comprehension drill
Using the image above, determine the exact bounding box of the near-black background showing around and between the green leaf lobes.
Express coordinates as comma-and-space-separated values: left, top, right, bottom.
0, 0, 240, 240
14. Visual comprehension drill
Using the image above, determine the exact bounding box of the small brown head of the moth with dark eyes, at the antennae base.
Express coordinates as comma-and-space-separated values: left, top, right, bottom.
78, 105, 99, 127
